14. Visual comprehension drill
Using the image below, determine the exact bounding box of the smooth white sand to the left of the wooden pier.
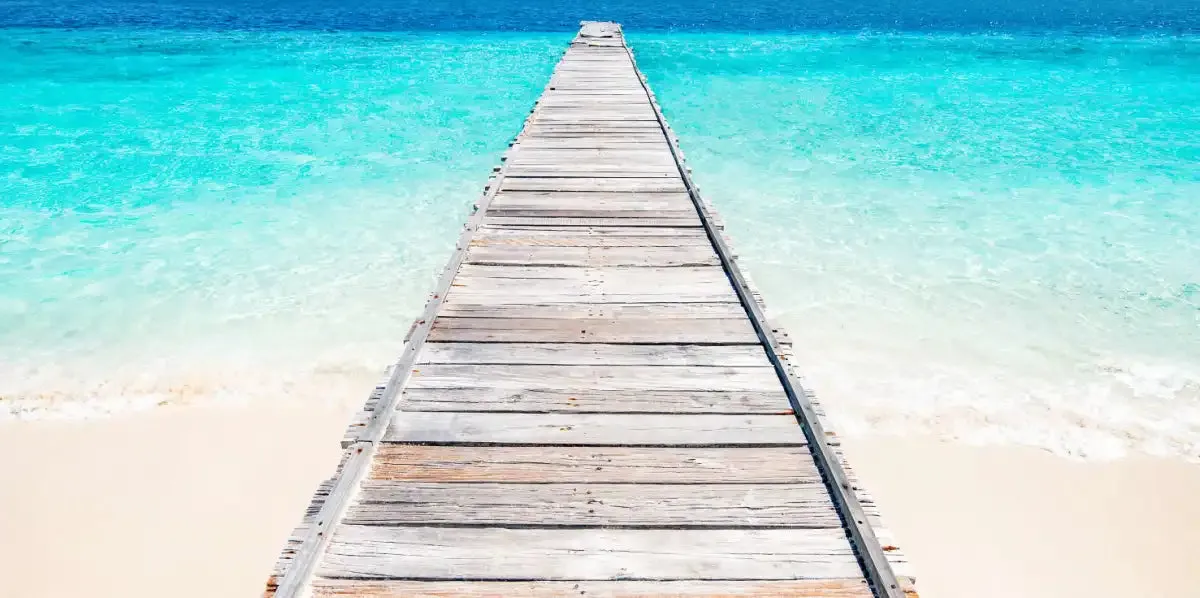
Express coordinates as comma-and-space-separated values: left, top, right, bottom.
0, 407, 349, 598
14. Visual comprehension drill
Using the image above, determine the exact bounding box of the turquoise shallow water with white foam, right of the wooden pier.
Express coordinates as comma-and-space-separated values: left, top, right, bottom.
634, 35, 1200, 458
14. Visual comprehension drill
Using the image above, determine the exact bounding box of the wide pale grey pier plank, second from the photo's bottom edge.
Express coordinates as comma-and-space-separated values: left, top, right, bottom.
319, 525, 859, 580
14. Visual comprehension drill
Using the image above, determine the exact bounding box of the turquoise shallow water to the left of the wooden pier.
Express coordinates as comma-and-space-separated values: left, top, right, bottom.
0, 30, 570, 413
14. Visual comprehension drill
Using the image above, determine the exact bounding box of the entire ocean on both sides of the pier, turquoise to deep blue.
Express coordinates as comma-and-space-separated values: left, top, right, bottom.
0, 0, 1200, 460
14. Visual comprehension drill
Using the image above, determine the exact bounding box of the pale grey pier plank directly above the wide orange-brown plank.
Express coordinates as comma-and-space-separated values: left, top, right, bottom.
384, 412, 804, 447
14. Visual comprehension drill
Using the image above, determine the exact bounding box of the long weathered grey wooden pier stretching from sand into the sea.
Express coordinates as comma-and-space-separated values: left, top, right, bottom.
266, 23, 916, 598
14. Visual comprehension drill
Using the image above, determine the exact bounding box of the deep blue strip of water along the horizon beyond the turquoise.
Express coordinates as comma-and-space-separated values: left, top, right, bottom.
7, 0, 1200, 34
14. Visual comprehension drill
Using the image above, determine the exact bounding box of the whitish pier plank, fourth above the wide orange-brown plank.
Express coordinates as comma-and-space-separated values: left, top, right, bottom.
418, 341, 770, 367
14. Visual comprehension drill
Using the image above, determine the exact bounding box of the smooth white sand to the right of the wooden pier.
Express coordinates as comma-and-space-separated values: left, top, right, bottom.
846, 438, 1200, 598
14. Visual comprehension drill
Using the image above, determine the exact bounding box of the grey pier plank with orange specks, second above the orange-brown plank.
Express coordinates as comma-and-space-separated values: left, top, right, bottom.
400, 388, 792, 414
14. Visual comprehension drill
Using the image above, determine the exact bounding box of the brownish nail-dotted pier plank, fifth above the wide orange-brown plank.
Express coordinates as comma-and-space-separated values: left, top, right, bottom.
430, 316, 758, 345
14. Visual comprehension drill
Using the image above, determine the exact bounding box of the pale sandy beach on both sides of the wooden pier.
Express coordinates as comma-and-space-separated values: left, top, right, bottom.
0, 406, 1200, 598
